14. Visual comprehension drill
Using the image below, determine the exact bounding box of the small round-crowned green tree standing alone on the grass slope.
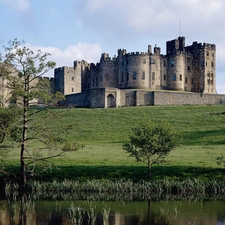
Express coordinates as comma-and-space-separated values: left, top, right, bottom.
122, 118, 178, 178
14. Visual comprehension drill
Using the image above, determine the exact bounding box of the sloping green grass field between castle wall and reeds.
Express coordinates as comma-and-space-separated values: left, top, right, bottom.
2, 105, 225, 179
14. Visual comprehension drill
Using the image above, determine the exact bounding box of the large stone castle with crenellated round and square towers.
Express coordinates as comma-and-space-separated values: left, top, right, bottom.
54, 37, 220, 107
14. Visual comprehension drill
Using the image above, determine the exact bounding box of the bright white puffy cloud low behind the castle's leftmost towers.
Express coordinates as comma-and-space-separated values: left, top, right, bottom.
26, 42, 102, 77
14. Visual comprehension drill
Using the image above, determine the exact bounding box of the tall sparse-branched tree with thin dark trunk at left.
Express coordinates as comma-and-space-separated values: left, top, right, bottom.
0, 39, 77, 186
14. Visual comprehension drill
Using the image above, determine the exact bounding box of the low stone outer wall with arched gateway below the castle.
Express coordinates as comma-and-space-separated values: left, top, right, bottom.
62, 88, 225, 108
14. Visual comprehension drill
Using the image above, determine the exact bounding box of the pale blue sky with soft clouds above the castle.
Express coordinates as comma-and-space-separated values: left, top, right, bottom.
0, 0, 225, 94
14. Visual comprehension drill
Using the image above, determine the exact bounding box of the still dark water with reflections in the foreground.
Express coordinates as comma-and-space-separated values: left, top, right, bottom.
0, 200, 225, 225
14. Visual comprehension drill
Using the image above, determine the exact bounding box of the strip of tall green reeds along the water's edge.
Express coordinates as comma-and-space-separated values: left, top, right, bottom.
5, 178, 225, 201
